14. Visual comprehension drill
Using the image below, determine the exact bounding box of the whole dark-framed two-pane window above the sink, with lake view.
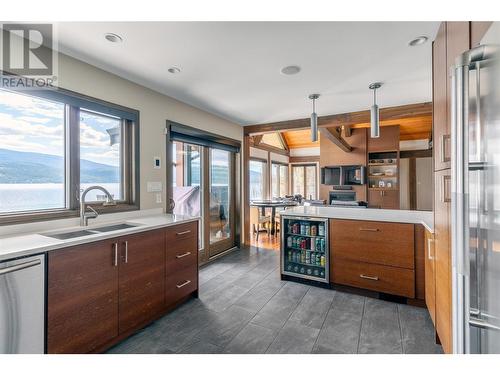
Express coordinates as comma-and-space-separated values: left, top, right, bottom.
0, 90, 139, 224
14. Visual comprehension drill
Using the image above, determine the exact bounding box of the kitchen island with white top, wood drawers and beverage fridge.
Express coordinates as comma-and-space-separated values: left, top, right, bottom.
281, 206, 434, 300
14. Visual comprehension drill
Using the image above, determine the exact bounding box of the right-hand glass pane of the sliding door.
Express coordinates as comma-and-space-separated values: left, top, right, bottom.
210, 149, 231, 244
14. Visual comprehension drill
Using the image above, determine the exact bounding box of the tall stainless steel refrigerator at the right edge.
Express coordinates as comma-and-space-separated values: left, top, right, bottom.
450, 22, 500, 353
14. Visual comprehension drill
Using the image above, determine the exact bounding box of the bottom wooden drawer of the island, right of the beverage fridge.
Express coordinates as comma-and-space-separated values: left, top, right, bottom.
331, 258, 415, 298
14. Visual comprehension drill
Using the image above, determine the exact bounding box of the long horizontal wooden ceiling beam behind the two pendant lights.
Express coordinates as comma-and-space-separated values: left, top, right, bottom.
243, 102, 432, 135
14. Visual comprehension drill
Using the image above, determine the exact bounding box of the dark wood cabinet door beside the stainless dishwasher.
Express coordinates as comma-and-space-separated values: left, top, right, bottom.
47, 240, 119, 353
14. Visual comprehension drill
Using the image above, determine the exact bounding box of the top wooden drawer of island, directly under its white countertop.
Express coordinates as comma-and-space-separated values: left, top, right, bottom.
330, 219, 415, 269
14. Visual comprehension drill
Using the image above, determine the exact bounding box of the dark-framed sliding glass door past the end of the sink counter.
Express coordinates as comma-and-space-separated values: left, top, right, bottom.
167, 141, 235, 263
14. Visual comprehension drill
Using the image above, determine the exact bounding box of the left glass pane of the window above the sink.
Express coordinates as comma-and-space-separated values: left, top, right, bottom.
0, 90, 65, 213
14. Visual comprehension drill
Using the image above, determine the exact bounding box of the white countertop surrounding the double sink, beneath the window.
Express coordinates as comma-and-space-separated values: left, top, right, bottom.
0, 214, 199, 261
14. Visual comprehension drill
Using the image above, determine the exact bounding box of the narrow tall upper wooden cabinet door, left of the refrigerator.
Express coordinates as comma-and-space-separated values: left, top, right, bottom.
432, 22, 451, 171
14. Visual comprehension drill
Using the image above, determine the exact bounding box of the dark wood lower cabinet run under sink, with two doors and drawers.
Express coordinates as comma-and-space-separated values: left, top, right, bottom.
47, 223, 198, 353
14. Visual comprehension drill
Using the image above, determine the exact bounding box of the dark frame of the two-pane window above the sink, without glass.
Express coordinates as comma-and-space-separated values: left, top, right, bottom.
0, 88, 140, 225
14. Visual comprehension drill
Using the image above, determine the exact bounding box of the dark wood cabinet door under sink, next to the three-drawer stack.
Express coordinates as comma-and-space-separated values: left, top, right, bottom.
119, 230, 165, 333
